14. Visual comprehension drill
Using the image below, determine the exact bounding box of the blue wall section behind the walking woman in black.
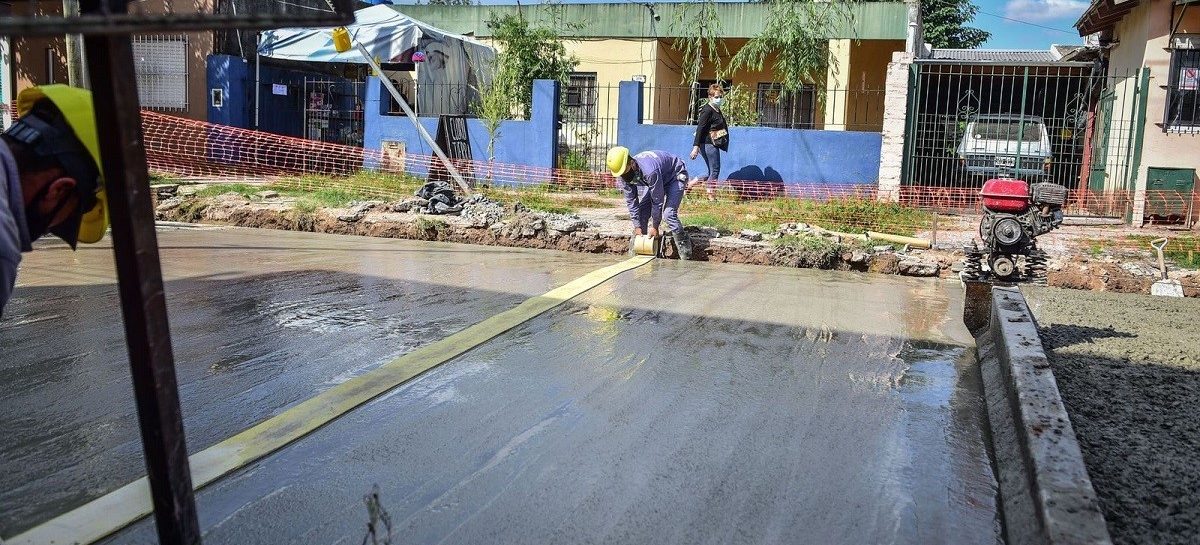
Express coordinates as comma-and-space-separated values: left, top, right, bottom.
617, 82, 883, 185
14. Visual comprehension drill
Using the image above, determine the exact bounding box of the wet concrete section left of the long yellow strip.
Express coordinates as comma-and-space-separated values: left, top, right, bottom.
0, 228, 611, 537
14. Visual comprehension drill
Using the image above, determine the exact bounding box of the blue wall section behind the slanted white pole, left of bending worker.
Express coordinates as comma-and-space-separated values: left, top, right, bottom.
364, 77, 559, 181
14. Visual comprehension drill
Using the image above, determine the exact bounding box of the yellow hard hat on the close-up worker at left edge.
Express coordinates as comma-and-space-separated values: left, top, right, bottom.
17, 85, 108, 247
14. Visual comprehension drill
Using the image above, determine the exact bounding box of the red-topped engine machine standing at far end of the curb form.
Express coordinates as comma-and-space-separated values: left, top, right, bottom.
962, 179, 1067, 283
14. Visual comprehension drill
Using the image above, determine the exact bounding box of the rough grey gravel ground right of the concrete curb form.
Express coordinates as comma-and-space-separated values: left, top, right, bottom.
1026, 288, 1200, 544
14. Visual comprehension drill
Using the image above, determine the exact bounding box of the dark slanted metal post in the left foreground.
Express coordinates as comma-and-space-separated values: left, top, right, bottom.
82, 0, 200, 545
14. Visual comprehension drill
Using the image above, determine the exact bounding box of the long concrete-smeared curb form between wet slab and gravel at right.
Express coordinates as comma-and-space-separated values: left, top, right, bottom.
968, 287, 1112, 545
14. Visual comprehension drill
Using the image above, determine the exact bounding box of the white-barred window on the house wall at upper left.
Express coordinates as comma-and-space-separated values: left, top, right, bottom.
133, 35, 187, 112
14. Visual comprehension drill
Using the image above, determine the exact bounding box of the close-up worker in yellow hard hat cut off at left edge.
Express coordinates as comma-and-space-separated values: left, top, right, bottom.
0, 85, 108, 316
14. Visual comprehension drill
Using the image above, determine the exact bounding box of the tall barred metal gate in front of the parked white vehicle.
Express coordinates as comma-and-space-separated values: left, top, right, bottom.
902, 62, 1145, 216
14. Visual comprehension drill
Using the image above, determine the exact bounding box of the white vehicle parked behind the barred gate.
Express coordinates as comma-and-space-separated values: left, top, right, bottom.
956, 114, 1052, 179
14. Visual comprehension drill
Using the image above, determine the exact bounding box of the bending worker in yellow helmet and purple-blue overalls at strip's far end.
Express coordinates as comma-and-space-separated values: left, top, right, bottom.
607, 146, 691, 259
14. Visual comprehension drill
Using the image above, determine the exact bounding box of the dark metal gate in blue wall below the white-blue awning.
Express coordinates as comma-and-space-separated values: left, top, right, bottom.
304, 78, 366, 146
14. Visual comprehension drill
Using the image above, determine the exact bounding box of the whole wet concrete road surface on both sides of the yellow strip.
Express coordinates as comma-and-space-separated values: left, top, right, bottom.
7, 225, 1001, 544
